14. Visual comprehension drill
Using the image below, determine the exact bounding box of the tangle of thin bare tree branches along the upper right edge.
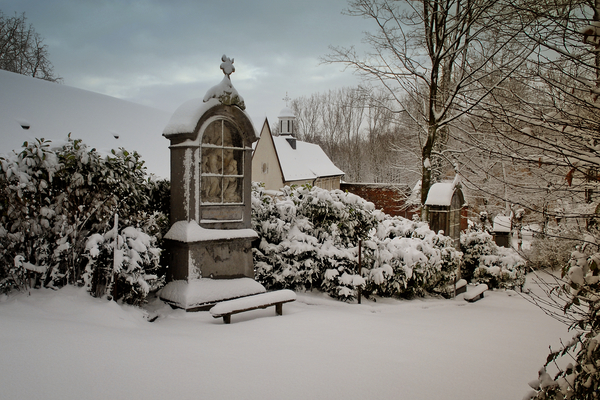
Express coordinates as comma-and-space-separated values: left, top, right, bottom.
455, 0, 600, 229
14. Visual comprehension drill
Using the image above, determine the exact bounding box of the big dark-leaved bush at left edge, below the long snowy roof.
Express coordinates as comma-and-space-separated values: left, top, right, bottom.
0, 136, 167, 300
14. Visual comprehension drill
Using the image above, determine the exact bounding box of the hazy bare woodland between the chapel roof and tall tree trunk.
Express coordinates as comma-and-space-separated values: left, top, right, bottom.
291, 87, 411, 183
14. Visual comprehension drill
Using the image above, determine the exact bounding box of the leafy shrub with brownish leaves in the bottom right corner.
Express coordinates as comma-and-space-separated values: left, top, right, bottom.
524, 240, 600, 400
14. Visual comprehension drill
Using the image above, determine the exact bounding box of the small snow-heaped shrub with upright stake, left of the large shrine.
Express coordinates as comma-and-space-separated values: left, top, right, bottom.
83, 226, 164, 305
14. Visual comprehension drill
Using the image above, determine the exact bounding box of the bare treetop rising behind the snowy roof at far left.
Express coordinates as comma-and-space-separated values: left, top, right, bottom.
0, 11, 61, 82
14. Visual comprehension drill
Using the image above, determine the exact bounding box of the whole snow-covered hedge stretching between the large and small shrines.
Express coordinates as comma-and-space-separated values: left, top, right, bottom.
252, 185, 460, 300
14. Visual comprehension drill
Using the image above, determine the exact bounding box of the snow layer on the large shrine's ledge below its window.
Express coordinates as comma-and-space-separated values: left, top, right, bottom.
165, 220, 258, 243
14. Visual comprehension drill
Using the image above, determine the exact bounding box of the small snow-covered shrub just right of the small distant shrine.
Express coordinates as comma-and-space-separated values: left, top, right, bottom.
460, 230, 525, 288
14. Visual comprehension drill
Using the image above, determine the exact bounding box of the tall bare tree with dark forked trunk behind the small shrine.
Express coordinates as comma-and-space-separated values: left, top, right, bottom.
325, 0, 529, 217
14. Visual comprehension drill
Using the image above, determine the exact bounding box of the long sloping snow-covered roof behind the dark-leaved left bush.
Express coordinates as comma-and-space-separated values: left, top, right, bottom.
0, 70, 170, 178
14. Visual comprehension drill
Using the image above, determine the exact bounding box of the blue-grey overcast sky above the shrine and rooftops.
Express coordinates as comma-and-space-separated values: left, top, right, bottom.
0, 0, 376, 129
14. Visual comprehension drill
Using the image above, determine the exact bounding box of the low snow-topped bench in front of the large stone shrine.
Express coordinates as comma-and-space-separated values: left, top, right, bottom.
210, 289, 296, 324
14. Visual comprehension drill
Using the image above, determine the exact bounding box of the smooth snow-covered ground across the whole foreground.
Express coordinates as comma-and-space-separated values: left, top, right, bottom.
0, 276, 572, 400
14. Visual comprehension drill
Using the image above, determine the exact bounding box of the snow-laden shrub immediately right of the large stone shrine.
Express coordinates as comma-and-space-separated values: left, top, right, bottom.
252, 184, 375, 299
